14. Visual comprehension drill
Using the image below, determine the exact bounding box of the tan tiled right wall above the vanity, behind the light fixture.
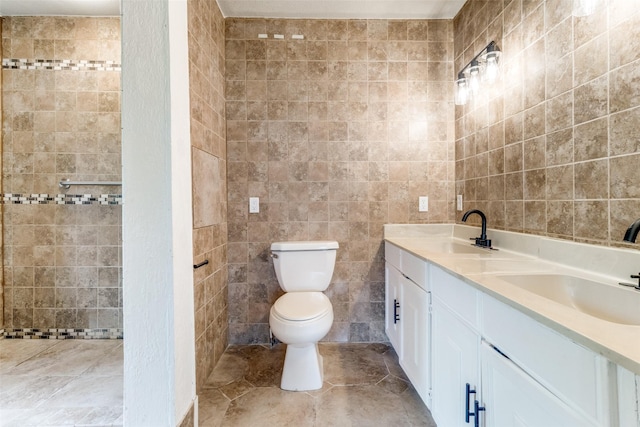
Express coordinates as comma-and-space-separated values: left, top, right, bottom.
454, 0, 640, 245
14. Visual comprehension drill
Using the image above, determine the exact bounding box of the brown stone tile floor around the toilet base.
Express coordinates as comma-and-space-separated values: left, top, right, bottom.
199, 343, 436, 427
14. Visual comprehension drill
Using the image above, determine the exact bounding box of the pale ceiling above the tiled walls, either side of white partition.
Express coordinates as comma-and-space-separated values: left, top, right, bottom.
0, 0, 466, 19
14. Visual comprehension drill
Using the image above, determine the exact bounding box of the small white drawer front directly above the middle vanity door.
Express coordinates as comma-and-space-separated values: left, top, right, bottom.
429, 265, 479, 331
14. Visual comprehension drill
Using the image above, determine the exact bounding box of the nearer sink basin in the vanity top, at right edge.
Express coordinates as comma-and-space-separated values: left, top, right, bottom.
498, 274, 640, 326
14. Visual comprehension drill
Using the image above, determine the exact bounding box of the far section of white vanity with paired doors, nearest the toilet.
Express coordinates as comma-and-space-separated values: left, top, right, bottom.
385, 243, 431, 405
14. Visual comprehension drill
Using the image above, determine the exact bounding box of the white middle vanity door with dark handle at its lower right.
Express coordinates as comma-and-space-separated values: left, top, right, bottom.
431, 296, 480, 427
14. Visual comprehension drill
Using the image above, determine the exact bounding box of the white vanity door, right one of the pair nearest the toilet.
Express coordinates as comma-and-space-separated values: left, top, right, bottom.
400, 277, 431, 404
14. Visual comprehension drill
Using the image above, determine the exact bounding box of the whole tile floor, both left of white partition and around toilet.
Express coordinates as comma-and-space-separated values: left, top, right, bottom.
0, 340, 435, 427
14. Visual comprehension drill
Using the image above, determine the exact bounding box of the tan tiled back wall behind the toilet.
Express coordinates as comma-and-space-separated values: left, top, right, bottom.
226, 19, 455, 343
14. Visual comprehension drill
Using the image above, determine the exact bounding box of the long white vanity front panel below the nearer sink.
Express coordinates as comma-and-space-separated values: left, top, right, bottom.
482, 294, 609, 425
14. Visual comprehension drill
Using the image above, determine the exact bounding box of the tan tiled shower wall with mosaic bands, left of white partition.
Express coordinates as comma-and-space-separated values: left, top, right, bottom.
2, 17, 122, 332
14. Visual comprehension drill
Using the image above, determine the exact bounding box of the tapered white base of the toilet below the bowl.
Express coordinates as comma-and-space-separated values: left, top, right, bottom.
280, 343, 323, 391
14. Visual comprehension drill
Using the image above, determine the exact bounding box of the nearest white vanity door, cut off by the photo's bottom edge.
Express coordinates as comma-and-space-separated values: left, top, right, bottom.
480, 342, 596, 427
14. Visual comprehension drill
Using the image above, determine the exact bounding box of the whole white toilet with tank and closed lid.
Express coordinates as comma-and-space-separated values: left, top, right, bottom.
269, 241, 338, 391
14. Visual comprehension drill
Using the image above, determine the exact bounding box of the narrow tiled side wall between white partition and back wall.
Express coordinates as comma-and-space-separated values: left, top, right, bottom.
187, 0, 229, 391
